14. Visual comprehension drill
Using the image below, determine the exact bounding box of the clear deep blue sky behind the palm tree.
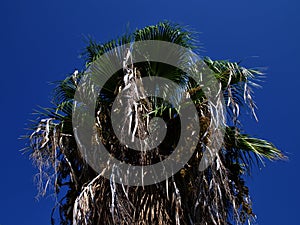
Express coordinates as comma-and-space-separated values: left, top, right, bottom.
0, 0, 300, 225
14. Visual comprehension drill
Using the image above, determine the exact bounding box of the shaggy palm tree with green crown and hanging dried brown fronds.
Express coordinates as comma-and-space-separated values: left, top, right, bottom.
27, 22, 285, 224
